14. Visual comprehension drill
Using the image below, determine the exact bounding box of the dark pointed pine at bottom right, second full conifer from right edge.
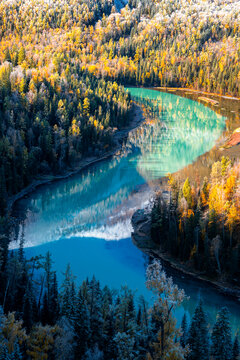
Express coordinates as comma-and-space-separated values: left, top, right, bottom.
211, 307, 232, 360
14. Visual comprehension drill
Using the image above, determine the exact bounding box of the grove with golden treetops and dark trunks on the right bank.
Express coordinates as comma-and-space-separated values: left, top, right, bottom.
151, 157, 240, 286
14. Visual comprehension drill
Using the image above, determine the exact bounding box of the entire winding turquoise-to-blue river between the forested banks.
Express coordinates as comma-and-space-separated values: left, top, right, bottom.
12, 88, 240, 330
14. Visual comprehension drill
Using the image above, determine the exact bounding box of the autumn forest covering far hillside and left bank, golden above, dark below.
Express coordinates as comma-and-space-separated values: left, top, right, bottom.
0, 0, 240, 215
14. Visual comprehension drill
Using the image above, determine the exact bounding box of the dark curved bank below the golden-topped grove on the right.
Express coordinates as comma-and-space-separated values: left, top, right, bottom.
131, 209, 240, 302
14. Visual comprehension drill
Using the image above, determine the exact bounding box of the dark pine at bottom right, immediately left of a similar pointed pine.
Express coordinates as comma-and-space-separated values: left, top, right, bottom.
188, 302, 209, 360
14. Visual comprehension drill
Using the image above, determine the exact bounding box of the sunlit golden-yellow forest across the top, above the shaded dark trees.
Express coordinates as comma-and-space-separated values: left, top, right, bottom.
0, 0, 240, 96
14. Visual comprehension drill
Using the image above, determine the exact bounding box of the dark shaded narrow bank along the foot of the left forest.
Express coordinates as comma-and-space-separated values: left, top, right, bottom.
7, 103, 145, 214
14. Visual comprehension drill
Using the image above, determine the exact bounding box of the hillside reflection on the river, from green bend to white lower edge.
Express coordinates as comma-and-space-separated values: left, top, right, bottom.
13, 89, 224, 246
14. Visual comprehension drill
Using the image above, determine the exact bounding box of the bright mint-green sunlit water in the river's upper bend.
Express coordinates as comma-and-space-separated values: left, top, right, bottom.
125, 88, 225, 180
